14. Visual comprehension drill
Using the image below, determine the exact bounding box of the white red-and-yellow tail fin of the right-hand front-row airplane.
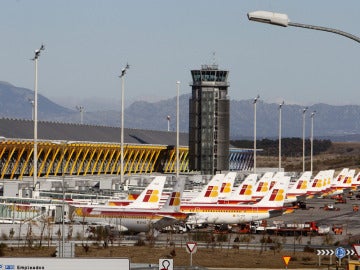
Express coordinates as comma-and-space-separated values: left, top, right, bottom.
254, 176, 290, 208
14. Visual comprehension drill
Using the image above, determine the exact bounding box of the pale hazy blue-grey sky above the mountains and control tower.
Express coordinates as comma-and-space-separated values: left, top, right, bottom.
0, 0, 360, 109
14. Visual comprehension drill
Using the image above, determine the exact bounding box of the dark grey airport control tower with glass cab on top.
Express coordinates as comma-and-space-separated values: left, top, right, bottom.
189, 65, 230, 174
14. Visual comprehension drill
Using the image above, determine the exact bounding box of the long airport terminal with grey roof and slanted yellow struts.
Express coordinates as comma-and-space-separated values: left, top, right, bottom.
0, 118, 253, 179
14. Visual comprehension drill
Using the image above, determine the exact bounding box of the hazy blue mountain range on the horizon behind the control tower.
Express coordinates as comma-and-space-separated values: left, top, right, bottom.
0, 82, 360, 141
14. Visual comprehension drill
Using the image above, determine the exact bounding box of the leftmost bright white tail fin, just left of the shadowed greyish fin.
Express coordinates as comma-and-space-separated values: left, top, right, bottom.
124, 176, 166, 209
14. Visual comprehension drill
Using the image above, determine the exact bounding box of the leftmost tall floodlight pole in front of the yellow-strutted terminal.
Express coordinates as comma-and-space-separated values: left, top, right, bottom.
32, 44, 45, 196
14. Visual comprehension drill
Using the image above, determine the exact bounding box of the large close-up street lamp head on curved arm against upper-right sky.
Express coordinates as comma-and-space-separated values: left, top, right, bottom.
247, 11, 360, 43
